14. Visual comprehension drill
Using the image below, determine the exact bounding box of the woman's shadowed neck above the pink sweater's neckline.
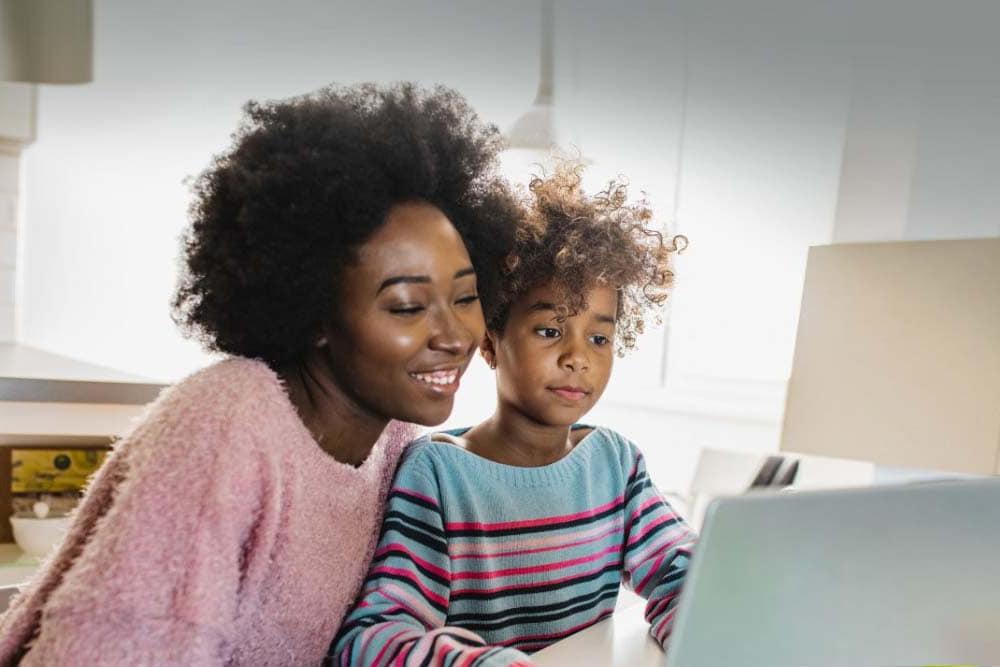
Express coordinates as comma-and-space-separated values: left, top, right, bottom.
279, 354, 389, 467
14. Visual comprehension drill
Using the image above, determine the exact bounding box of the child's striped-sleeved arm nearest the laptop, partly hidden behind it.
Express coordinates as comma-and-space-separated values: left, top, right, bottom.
624, 444, 697, 646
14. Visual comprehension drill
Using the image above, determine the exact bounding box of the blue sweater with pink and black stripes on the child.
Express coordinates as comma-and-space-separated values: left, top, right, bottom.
331, 428, 695, 666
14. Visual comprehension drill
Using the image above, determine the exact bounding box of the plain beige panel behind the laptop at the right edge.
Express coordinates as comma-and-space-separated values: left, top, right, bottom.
781, 238, 1000, 475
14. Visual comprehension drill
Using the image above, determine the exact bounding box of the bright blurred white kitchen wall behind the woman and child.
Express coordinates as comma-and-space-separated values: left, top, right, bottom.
0, 0, 1000, 496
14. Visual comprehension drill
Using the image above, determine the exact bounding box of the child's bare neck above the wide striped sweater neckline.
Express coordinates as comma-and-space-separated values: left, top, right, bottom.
465, 405, 576, 468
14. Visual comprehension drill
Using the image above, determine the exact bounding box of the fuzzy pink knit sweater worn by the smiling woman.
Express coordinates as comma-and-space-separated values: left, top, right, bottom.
0, 358, 414, 665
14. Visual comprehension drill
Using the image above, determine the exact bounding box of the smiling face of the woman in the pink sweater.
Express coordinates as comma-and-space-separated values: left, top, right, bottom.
324, 203, 485, 426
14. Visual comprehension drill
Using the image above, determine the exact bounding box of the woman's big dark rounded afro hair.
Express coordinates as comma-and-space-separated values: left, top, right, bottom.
173, 83, 519, 368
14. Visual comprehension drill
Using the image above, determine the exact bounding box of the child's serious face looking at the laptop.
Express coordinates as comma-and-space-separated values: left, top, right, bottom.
483, 285, 618, 426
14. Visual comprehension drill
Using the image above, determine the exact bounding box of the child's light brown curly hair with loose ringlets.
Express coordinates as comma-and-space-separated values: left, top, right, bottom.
480, 159, 687, 355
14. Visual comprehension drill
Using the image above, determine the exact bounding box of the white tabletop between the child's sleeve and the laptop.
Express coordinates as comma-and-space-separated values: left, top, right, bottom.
531, 598, 665, 667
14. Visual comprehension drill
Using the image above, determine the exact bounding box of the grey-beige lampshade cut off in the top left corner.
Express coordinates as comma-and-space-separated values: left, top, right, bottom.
0, 0, 93, 83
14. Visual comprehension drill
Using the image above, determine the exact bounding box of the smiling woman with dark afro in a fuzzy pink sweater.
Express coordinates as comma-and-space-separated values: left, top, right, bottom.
0, 85, 516, 665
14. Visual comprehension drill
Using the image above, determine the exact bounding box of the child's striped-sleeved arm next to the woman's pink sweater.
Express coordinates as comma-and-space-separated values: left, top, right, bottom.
330, 461, 530, 667
